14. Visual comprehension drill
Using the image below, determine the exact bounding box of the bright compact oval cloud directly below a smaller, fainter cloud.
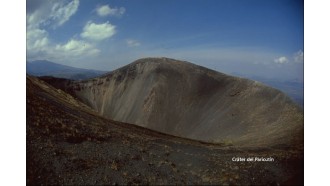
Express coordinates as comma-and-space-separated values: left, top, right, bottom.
80, 21, 116, 41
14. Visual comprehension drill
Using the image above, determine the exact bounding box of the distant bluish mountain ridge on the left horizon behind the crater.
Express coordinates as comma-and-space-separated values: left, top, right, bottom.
26, 60, 106, 80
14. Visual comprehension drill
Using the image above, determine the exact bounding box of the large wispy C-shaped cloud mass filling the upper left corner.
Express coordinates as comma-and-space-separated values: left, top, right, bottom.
26, 0, 100, 61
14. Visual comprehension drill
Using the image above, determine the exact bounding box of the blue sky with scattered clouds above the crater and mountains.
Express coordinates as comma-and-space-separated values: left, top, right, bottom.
26, 0, 304, 81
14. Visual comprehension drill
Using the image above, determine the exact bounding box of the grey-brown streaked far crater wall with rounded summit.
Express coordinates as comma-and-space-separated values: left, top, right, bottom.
58, 58, 303, 146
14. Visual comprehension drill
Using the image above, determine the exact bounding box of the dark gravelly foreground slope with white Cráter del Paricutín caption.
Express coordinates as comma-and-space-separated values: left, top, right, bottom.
26, 77, 303, 185
